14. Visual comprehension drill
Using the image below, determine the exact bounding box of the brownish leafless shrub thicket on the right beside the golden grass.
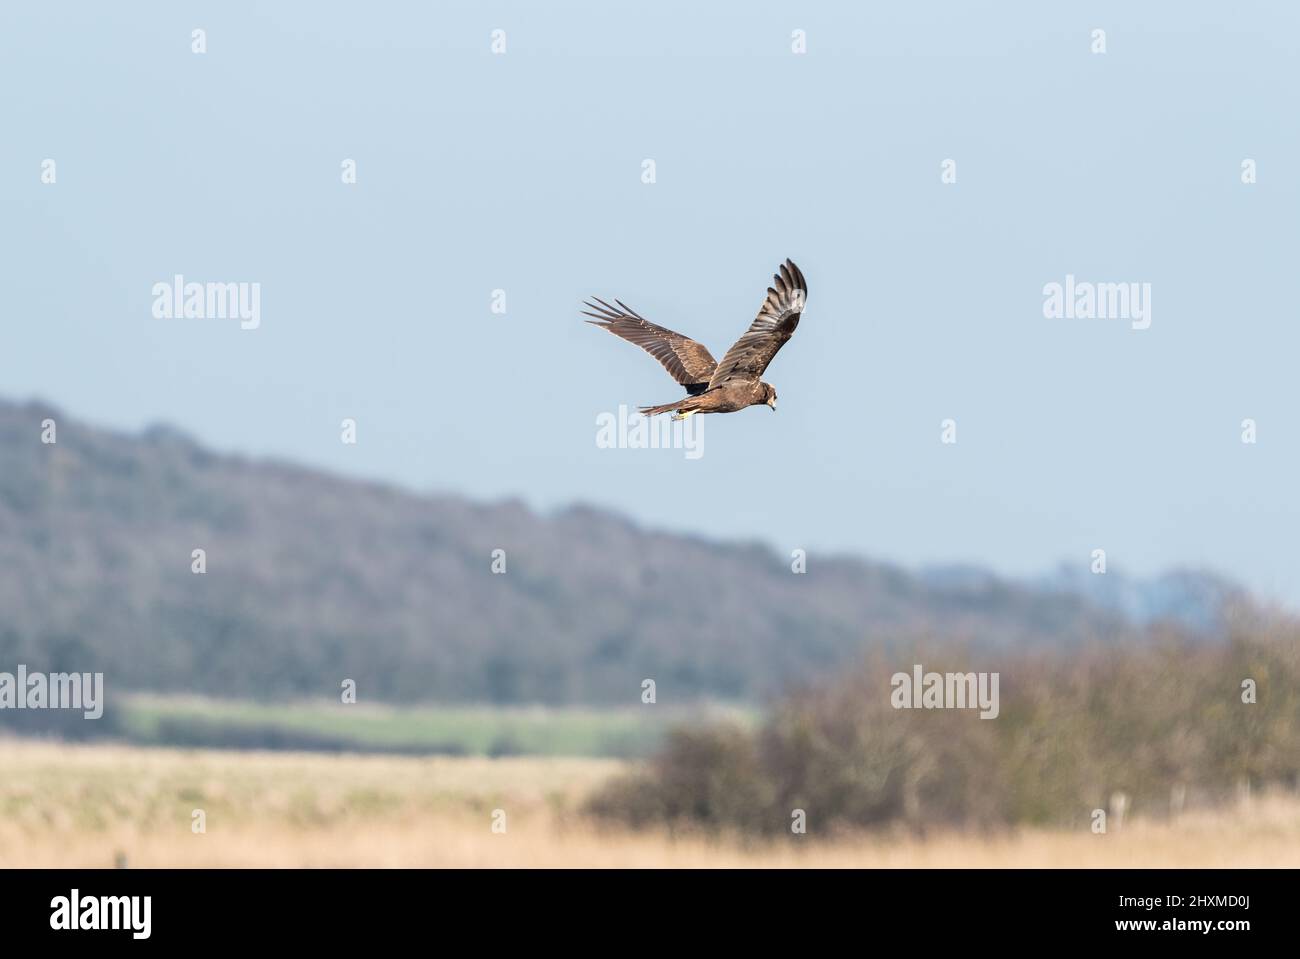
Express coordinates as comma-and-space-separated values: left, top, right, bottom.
590, 625, 1300, 834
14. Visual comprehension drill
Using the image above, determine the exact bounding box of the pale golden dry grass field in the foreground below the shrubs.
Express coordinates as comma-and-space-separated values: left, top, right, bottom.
0, 738, 1300, 868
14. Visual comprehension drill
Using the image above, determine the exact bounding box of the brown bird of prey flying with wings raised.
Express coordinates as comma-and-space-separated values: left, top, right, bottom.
582, 260, 807, 420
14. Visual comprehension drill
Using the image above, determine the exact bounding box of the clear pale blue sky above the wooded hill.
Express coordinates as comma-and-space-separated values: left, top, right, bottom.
0, 1, 1300, 603
